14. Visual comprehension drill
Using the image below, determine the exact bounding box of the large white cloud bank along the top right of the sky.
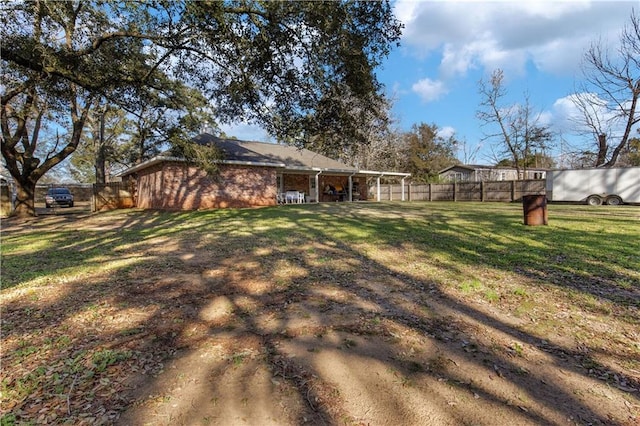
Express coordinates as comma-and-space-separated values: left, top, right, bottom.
394, 1, 633, 76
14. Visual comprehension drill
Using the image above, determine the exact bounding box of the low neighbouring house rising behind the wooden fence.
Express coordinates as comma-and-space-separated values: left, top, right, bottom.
438, 164, 547, 182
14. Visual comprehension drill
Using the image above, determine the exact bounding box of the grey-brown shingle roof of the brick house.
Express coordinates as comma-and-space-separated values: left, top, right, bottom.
194, 133, 356, 171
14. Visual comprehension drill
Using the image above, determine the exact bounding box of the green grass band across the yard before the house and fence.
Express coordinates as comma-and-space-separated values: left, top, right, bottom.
2, 203, 640, 303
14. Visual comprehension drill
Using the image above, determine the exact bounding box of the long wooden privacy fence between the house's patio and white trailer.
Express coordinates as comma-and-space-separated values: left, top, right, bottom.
369, 179, 545, 202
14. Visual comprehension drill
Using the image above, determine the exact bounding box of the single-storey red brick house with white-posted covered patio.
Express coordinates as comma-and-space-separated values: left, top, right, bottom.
120, 133, 409, 210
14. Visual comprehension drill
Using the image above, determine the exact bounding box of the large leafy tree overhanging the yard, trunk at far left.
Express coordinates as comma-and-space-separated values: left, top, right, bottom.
0, 0, 401, 214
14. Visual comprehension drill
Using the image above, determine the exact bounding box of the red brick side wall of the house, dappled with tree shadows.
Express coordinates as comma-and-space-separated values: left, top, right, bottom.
137, 162, 276, 210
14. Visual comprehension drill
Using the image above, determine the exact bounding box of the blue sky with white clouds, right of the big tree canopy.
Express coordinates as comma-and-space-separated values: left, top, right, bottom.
223, 0, 640, 164
